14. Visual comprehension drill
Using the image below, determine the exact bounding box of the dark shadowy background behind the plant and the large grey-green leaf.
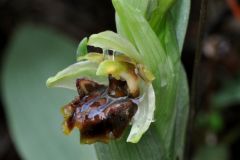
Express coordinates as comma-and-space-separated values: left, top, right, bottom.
0, 0, 240, 160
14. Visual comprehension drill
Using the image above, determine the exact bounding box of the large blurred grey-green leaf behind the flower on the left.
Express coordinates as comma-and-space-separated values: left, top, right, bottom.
1, 25, 97, 160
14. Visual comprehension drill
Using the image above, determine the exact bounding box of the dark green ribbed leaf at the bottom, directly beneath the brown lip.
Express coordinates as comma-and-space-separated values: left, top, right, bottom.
95, 127, 166, 160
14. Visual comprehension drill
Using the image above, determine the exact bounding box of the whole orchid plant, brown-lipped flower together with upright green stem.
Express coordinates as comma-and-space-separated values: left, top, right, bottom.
47, 0, 190, 159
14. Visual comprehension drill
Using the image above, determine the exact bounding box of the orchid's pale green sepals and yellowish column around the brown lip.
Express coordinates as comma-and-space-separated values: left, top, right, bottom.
47, 31, 155, 143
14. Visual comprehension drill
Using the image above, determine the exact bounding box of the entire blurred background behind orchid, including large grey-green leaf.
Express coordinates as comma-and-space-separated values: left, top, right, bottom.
0, 0, 240, 160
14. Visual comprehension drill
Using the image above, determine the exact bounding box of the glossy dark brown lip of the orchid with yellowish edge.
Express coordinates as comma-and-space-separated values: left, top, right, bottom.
62, 76, 137, 144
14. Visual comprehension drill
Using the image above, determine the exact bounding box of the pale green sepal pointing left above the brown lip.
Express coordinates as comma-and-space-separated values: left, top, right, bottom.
47, 61, 108, 90
